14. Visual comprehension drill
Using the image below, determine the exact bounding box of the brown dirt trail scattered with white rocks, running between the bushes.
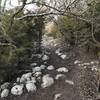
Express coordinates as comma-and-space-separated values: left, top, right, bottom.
0, 36, 98, 100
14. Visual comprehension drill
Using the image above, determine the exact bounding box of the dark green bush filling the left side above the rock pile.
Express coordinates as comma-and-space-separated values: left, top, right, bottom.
0, 11, 43, 83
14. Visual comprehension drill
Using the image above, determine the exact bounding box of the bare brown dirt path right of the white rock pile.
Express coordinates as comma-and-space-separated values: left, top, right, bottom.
27, 36, 82, 100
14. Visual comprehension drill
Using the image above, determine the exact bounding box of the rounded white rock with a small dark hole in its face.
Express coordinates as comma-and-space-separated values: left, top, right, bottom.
11, 84, 24, 95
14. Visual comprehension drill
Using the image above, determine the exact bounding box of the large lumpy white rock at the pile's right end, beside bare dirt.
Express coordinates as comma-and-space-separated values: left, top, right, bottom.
41, 74, 54, 88
